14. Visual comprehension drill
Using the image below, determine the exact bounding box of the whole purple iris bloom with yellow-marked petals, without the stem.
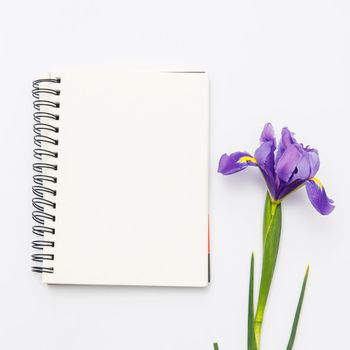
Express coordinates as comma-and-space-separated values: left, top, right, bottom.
218, 123, 334, 215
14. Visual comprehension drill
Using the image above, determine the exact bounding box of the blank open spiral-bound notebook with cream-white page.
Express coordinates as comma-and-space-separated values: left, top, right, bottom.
32, 70, 209, 287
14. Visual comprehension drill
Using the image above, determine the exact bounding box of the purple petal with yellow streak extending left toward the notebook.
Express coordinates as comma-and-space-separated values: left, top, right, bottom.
218, 152, 258, 175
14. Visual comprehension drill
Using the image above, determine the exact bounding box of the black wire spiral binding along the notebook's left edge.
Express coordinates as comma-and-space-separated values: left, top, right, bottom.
32, 78, 61, 273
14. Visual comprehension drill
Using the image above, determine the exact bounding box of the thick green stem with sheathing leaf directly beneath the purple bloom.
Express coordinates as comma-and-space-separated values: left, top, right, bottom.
254, 193, 282, 349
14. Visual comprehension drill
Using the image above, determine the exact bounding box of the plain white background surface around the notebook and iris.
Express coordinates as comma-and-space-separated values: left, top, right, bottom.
0, 0, 350, 350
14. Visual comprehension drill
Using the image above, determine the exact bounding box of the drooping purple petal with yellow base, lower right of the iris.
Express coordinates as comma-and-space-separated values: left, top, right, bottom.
306, 178, 334, 215
